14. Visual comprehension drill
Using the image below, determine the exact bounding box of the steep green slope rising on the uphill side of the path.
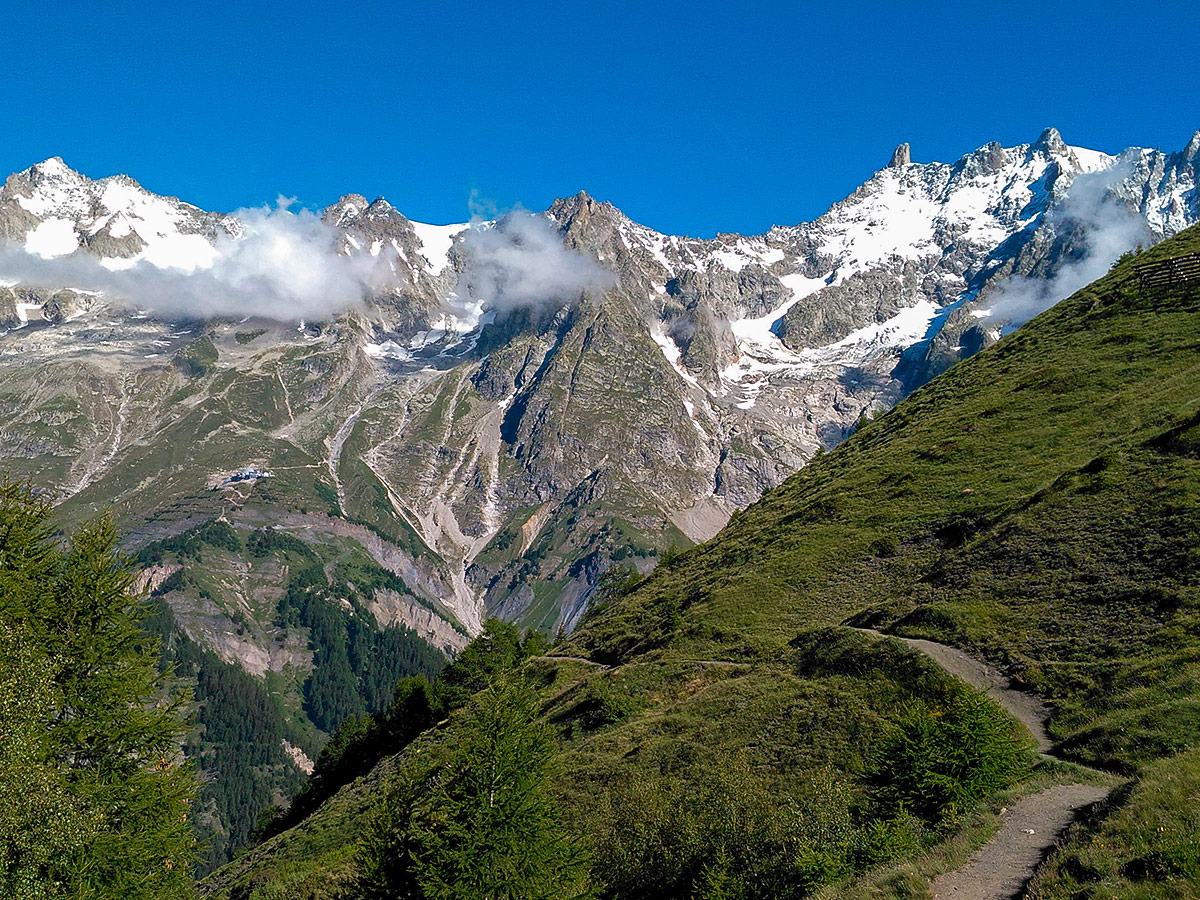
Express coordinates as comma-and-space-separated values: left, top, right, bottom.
572, 229, 1200, 769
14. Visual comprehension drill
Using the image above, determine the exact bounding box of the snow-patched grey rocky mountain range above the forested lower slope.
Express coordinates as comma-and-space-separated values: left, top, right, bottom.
0, 130, 1200, 666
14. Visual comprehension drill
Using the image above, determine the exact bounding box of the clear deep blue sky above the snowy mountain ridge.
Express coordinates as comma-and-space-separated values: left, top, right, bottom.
9, 0, 1200, 236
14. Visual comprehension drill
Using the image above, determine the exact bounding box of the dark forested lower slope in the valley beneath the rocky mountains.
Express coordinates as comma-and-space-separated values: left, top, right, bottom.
134, 520, 445, 872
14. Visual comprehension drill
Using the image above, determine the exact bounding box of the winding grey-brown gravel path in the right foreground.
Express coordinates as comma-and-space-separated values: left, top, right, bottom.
856, 629, 1109, 900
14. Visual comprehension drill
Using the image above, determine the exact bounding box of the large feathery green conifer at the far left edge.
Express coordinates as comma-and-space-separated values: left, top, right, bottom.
0, 482, 196, 900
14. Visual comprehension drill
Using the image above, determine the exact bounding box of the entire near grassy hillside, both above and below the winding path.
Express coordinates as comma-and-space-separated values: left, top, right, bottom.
201, 229, 1200, 898
